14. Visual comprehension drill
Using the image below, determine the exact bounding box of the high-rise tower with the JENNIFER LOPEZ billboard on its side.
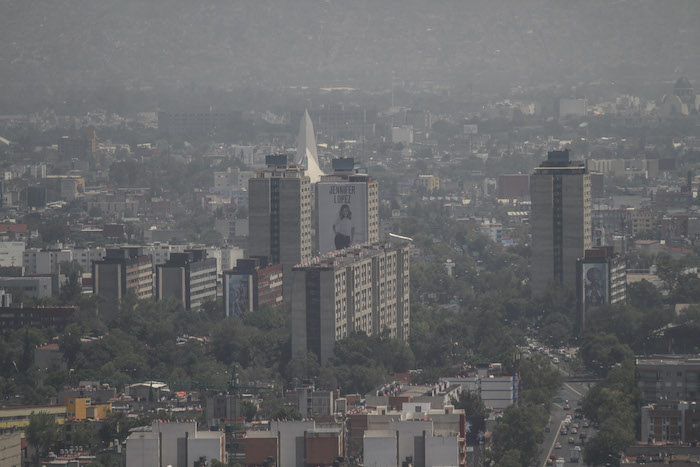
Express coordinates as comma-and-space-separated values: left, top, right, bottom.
316, 158, 379, 254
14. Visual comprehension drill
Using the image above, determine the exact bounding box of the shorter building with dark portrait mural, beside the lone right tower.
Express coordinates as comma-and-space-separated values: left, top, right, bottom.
576, 246, 627, 333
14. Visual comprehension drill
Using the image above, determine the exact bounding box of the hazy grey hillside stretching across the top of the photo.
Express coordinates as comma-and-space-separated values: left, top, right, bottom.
0, 0, 700, 104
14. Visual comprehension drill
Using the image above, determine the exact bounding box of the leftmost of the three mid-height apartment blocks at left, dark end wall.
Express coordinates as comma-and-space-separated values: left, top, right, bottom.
92, 247, 153, 320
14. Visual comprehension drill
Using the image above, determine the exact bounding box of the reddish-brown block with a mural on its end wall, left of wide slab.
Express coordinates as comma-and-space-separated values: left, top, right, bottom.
223, 258, 284, 317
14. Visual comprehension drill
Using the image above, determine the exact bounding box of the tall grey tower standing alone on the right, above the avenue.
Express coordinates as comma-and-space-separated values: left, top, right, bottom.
530, 149, 592, 294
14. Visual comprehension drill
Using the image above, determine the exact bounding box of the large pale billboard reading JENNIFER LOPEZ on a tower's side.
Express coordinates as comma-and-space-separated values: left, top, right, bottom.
316, 182, 368, 254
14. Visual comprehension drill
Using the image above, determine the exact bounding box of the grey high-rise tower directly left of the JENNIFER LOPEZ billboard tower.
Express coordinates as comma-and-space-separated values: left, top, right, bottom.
248, 155, 311, 272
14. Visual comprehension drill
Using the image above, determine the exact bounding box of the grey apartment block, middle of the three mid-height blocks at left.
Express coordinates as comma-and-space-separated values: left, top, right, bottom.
156, 250, 218, 310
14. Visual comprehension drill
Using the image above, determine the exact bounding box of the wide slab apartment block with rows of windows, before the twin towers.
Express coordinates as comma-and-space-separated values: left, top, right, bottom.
291, 244, 410, 364
